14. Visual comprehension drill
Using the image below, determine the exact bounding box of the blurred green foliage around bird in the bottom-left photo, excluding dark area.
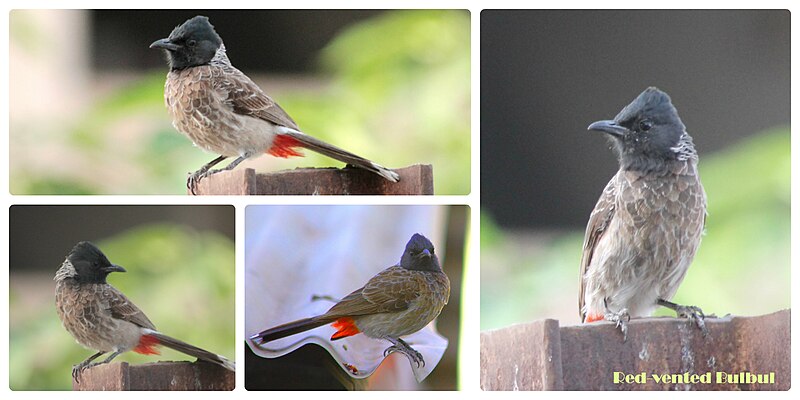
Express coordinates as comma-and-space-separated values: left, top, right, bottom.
9, 224, 236, 390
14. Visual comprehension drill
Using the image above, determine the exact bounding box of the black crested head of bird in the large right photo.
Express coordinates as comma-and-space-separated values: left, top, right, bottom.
589, 87, 693, 171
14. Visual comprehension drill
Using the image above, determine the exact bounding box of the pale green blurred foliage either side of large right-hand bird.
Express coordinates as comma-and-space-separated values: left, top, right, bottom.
481, 128, 791, 329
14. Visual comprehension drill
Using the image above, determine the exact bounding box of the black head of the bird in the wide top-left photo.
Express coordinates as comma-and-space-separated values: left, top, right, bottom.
150, 15, 222, 70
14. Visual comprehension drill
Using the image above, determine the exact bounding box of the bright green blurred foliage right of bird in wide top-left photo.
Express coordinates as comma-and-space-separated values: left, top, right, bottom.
280, 10, 471, 194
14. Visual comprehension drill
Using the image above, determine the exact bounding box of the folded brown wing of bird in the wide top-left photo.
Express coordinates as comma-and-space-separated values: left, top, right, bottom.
213, 66, 300, 130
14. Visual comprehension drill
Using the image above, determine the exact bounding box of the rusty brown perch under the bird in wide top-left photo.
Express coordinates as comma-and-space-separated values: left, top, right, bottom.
189, 164, 433, 195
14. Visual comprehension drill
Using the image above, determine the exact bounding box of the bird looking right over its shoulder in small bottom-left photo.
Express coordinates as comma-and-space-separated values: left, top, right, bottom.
54, 241, 235, 381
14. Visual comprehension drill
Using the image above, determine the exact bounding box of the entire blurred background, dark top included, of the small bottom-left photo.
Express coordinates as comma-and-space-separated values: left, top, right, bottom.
9, 206, 236, 390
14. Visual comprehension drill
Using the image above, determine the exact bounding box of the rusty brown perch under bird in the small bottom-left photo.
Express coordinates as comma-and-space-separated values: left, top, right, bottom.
72, 361, 236, 390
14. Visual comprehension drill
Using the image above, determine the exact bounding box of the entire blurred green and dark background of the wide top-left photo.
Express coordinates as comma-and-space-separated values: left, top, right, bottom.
10, 10, 470, 194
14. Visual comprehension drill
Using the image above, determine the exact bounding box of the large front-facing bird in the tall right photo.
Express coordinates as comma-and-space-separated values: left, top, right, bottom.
578, 87, 708, 340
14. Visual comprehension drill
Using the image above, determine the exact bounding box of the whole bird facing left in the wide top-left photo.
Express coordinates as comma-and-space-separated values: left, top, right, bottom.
150, 15, 400, 194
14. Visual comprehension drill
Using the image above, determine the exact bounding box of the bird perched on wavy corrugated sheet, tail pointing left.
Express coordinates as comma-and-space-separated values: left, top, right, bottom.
250, 233, 450, 367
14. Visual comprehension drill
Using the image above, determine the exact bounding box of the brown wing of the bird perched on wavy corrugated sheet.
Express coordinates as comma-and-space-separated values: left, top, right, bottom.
325, 266, 420, 318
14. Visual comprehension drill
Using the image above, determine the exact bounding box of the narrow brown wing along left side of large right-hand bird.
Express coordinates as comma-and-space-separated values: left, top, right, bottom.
578, 176, 617, 322
